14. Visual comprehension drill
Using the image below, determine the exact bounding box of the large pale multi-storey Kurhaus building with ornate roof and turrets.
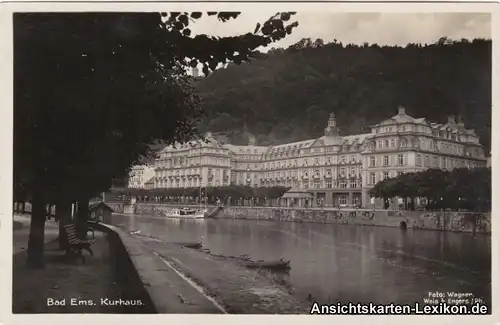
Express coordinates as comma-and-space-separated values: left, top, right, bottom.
146, 107, 487, 206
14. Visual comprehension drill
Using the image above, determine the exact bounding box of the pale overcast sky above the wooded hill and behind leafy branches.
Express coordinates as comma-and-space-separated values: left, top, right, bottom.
191, 12, 491, 47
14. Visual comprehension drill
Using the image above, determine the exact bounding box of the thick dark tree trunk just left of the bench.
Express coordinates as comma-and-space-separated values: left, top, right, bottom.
26, 180, 46, 268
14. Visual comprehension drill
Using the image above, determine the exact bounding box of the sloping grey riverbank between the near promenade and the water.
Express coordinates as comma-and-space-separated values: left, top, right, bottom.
131, 232, 310, 314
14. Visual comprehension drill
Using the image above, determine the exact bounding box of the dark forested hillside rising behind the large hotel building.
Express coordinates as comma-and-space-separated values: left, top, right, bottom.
197, 38, 491, 150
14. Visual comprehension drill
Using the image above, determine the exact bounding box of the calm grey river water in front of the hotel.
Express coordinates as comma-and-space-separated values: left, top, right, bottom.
113, 215, 491, 305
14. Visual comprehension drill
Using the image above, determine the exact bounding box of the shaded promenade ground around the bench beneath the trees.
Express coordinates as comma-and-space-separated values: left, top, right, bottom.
12, 216, 150, 313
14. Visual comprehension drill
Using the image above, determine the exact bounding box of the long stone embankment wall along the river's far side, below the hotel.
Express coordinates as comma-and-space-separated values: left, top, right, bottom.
110, 203, 491, 233
